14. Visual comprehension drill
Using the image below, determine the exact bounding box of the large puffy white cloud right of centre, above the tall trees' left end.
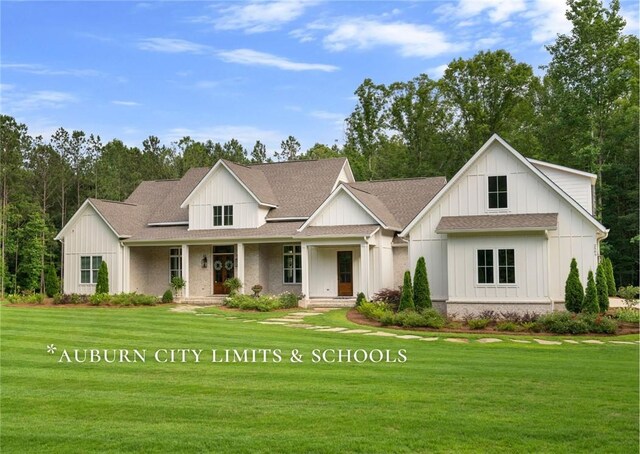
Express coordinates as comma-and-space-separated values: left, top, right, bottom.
324, 18, 461, 57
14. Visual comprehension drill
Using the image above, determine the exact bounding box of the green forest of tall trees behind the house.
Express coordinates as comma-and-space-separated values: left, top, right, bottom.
0, 0, 640, 293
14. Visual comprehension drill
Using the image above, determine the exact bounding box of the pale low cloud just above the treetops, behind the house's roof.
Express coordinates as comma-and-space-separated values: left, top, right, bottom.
165, 125, 283, 151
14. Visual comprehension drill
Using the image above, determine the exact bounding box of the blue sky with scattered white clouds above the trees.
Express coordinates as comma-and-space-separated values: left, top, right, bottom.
0, 0, 638, 152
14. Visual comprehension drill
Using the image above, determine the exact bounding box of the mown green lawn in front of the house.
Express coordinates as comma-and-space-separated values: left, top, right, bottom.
0, 306, 639, 453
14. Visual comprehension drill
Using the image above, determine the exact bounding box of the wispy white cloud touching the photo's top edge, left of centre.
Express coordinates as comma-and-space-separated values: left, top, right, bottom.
209, 0, 316, 33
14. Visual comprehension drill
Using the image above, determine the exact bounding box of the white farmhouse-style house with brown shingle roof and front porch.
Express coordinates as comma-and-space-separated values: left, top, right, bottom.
56, 135, 607, 312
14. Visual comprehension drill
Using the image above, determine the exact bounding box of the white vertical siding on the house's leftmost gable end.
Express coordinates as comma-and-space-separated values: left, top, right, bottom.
64, 205, 123, 294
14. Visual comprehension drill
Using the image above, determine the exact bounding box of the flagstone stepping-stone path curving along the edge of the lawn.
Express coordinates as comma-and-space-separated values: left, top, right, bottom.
181, 305, 640, 345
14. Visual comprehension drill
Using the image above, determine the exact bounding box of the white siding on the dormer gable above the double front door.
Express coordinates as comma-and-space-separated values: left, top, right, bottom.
189, 166, 268, 230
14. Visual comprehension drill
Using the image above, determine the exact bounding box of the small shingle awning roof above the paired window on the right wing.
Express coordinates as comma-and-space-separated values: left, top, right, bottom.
436, 213, 558, 233
